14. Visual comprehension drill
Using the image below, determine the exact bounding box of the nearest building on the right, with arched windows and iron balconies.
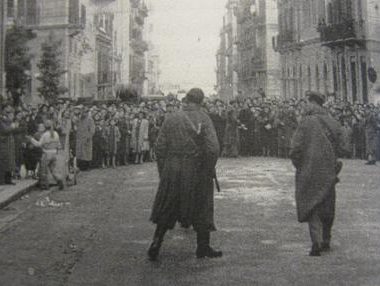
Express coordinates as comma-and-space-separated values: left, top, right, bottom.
273, 0, 380, 103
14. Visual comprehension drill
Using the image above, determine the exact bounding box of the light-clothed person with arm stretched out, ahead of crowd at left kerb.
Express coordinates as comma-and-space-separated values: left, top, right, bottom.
27, 119, 66, 190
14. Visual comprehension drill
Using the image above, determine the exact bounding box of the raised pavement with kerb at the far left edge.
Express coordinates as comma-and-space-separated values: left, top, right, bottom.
0, 179, 37, 209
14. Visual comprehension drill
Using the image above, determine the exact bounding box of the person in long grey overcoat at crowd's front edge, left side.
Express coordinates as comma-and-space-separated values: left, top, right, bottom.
76, 107, 95, 171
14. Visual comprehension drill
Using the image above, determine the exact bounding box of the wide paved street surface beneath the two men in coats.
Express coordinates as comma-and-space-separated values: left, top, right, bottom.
0, 158, 380, 286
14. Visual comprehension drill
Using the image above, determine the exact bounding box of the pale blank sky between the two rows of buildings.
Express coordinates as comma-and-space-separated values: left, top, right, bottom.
149, 0, 226, 93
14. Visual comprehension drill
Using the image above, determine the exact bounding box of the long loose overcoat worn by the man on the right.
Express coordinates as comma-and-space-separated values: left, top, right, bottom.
290, 106, 346, 222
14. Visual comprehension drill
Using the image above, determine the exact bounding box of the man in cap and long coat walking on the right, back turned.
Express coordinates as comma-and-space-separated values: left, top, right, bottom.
290, 92, 346, 256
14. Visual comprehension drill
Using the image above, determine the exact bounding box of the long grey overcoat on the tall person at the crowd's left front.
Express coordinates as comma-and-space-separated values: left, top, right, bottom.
76, 116, 95, 161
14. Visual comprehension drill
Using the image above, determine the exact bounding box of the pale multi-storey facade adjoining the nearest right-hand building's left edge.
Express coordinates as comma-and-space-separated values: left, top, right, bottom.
236, 0, 281, 98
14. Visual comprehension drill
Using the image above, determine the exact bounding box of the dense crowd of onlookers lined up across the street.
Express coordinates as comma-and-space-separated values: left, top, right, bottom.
0, 94, 380, 187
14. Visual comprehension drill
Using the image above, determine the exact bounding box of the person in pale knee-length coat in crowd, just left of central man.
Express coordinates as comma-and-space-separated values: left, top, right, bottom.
131, 111, 149, 164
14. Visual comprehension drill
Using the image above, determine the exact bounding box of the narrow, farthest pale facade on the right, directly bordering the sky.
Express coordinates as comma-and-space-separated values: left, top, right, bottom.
216, 0, 238, 101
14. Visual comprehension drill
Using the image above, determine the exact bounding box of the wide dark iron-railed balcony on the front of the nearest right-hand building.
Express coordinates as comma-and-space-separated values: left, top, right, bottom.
318, 19, 365, 47
